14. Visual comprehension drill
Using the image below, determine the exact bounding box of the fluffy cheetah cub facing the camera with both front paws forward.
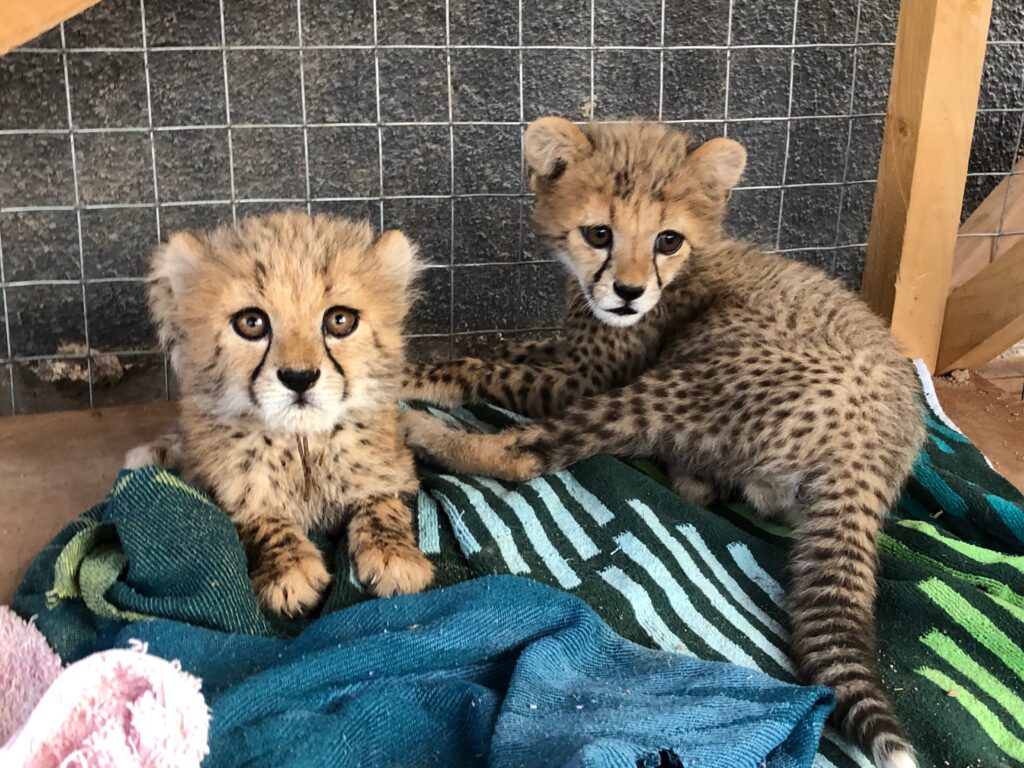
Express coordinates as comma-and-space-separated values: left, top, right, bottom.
127, 213, 433, 614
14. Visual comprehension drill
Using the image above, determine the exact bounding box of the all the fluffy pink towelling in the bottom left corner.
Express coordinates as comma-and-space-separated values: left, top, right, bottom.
0, 607, 210, 768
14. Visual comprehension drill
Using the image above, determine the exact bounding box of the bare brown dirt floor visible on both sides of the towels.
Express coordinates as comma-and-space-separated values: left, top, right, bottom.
0, 376, 1024, 603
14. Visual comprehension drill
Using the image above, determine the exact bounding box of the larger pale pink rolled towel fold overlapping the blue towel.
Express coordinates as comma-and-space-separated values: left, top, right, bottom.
0, 628, 209, 768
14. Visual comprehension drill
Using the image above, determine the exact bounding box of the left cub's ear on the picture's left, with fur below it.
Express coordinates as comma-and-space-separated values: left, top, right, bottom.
147, 232, 204, 372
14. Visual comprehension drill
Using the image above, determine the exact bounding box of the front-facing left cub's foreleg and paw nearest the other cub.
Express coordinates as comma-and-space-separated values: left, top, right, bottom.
348, 497, 434, 597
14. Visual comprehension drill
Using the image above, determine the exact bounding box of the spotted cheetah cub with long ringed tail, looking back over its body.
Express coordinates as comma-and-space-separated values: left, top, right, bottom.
402, 118, 925, 768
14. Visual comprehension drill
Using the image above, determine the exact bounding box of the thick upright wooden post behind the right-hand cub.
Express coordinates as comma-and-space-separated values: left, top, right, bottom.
861, 0, 992, 369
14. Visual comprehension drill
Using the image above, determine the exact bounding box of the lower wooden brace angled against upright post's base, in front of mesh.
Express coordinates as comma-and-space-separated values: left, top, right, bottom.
937, 242, 1024, 373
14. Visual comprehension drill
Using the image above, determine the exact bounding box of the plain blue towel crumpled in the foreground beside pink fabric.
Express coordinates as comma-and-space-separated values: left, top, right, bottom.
117, 575, 833, 768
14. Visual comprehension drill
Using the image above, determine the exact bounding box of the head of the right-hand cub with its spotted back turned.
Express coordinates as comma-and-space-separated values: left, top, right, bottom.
524, 118, 746, 326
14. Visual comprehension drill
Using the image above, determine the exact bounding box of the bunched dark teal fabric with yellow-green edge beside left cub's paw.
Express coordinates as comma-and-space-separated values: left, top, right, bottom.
14, 467, 274, 663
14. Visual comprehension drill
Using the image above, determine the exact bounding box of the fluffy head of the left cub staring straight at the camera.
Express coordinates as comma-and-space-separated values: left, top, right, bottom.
151, 213, 417, 434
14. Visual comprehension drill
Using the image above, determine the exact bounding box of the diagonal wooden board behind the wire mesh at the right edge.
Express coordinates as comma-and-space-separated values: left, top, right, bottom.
949, 159, 1024, 290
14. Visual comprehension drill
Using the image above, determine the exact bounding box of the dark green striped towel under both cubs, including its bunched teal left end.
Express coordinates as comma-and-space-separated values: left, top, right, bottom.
15, 387, 1024, 768
